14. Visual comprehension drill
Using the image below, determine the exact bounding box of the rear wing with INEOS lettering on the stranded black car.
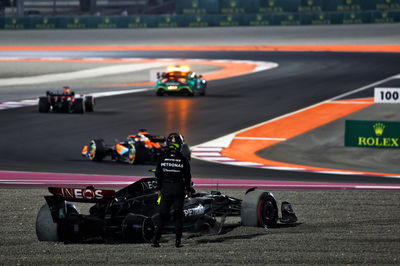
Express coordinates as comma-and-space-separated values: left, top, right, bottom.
49, 187, 115, 202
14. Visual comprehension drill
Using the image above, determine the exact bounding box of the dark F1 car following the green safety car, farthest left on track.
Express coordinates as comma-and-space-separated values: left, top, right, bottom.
39, 87, 96, 114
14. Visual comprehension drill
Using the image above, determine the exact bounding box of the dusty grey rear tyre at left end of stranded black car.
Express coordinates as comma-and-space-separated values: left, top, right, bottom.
36, 204, 59, 242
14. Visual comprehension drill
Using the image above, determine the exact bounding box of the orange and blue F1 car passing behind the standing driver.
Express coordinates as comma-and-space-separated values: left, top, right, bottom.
81, 129, 191, 164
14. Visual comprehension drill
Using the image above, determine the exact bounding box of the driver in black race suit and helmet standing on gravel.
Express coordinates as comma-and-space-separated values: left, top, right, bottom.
152, 133, 192, 247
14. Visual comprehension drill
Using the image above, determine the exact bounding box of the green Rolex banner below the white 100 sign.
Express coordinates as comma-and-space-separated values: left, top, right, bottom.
344, 120, 400, 149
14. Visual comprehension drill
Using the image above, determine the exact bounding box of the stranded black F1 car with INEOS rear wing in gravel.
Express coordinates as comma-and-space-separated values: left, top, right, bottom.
36, 178, 297, 243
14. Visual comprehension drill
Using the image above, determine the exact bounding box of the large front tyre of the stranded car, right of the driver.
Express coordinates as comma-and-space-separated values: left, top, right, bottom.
240, 190, 279, 227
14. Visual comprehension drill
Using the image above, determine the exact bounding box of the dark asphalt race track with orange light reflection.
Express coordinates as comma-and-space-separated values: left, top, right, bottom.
0, 52, 400, 183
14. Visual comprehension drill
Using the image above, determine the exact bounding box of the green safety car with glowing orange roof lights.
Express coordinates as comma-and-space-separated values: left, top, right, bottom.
155, 66, 207, 96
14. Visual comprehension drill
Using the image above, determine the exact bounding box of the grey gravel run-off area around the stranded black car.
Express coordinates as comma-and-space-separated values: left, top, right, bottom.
0, 188, 400, 265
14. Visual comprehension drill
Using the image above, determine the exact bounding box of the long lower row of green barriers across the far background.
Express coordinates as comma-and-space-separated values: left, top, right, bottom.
0, 10, 400, 30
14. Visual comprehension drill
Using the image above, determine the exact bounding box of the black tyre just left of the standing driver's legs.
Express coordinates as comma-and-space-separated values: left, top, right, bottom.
122, 213, 155, 243
